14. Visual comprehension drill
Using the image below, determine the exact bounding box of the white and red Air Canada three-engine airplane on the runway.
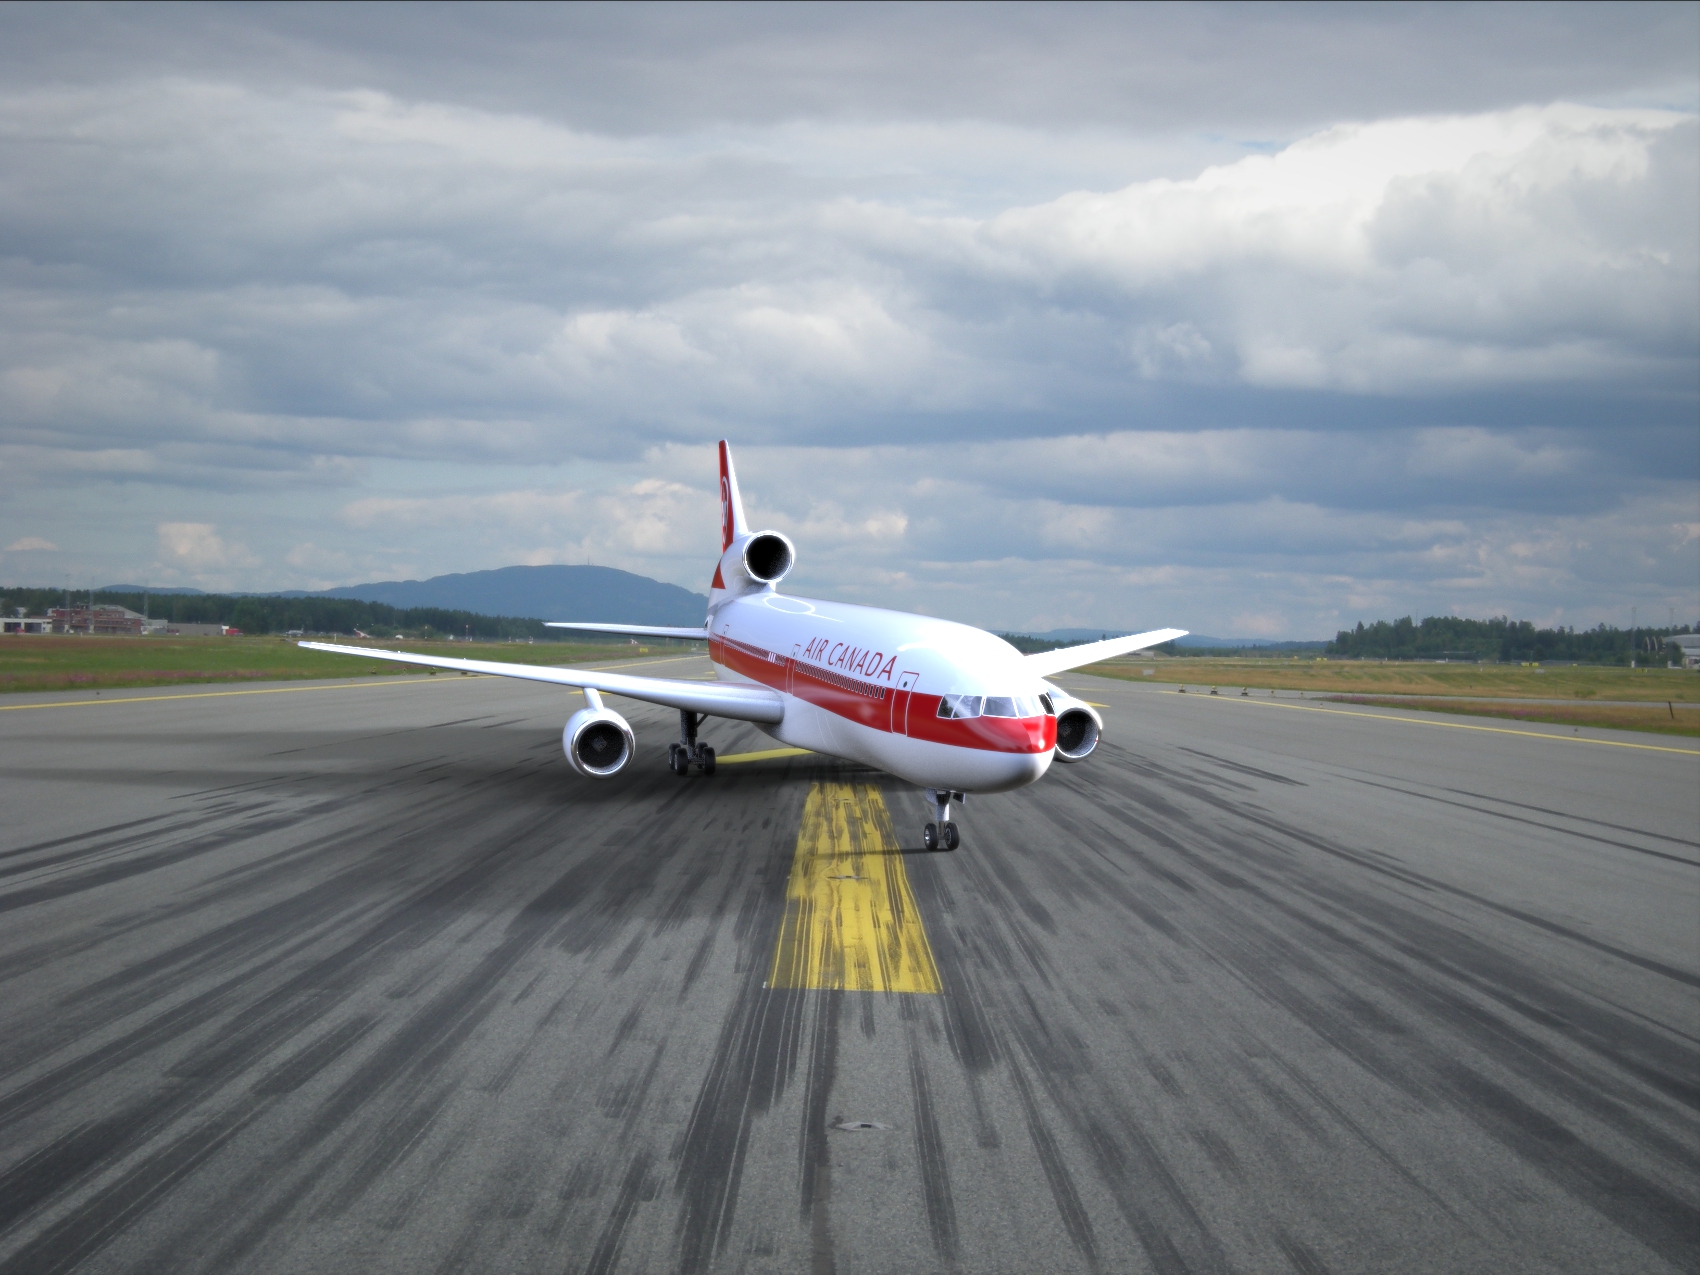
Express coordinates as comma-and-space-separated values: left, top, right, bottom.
299, 439, 1187, 850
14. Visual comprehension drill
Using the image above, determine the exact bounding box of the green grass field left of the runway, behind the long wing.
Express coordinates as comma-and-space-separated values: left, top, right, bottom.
0, 636, 685, 692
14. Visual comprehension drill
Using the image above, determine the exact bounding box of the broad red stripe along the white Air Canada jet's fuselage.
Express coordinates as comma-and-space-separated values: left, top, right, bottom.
709, 636, 1057, 753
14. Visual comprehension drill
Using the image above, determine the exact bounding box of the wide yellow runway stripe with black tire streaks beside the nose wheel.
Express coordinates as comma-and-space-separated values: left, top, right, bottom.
767, 784, 940, 993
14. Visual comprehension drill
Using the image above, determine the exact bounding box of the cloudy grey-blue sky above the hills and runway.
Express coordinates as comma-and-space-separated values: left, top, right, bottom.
0, 3, 1700, 638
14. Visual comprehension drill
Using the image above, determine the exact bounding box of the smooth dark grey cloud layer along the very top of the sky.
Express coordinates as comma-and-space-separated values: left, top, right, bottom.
0, 3, 1700, 138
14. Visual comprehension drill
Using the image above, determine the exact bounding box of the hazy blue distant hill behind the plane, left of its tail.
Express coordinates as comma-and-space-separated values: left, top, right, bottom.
283, 566, 709, 624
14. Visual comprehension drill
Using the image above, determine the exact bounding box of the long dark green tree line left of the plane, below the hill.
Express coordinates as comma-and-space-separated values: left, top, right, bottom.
0, 588, 612, 643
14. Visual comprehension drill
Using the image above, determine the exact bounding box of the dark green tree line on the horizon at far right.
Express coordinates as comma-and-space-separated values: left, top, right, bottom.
1324, 615, 1693, 665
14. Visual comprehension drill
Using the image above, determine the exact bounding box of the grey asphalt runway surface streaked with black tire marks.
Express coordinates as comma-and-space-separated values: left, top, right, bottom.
0, 660, 1700, 1275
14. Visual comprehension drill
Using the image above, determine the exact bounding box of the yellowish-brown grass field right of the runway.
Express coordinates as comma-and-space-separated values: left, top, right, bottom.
1081, 660, 1700, 736
